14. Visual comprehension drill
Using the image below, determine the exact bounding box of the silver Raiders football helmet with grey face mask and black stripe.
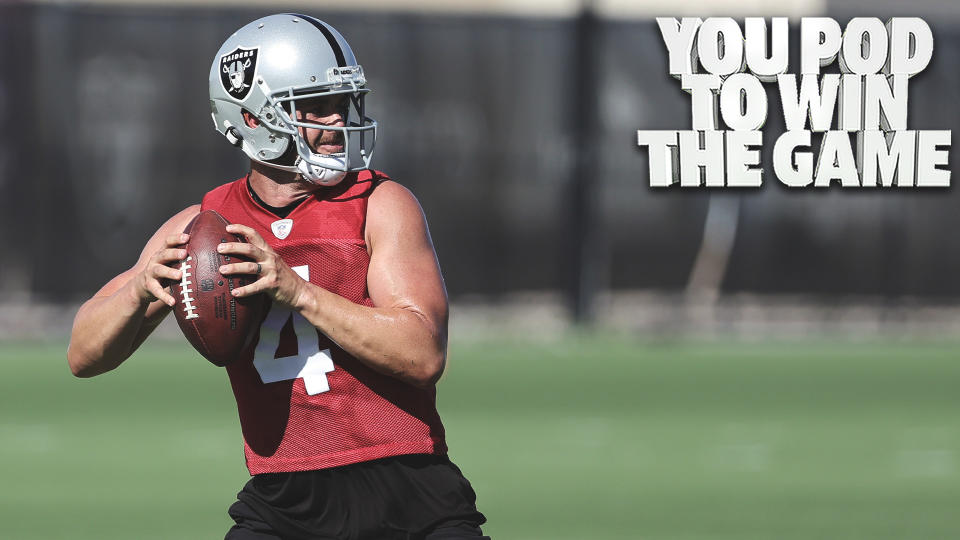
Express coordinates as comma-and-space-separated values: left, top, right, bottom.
209, 13, 377, 186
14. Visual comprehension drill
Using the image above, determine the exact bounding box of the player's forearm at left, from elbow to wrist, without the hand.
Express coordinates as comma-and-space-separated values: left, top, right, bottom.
67, 283, 159, 377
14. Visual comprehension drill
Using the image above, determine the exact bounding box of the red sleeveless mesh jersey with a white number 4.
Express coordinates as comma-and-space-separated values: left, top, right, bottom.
201, 170, 446, 474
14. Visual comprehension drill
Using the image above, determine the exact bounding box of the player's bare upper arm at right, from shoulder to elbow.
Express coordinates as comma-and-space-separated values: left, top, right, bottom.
367, 182, 447, 326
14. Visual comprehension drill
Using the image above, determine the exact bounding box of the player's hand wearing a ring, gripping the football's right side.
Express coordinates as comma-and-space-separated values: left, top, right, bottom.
217, 223, 306, 307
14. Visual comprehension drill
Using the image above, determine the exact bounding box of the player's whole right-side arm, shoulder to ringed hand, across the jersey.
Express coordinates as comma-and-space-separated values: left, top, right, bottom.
221, 182, 447, 387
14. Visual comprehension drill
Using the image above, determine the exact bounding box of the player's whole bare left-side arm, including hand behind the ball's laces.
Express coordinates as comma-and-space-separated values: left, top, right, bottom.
67, 205, 200, 377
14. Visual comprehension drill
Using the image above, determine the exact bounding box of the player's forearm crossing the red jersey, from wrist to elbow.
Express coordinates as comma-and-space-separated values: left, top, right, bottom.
294, 283, 447, 387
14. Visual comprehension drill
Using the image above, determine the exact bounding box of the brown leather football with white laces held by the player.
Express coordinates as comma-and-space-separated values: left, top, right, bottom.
170, 210, 266, 366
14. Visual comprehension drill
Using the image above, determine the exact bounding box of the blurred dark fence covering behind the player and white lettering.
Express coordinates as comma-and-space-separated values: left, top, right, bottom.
0, 4, 960, 308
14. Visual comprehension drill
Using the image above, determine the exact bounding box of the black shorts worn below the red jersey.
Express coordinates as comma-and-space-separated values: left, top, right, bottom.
225, 454, 489, 540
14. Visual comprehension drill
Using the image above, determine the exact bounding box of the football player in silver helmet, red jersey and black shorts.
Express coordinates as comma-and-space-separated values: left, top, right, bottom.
67, 14, 487, 540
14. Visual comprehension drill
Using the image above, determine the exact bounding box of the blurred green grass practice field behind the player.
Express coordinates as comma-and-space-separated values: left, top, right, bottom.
0, 336, 960, 540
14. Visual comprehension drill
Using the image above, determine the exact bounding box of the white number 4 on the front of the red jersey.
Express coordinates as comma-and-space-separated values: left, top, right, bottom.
253, 265, 334, 396
